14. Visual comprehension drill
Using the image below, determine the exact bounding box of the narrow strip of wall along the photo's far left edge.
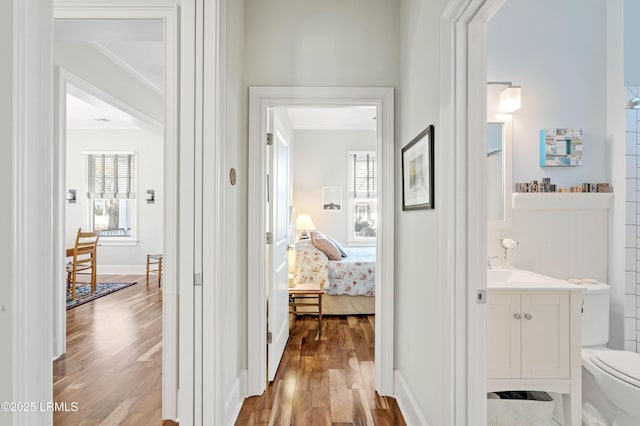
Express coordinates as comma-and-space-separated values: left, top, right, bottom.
0, 1, 14, 420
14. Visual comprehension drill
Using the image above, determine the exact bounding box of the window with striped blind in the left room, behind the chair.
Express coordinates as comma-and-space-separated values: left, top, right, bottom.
87, 153, 136, 241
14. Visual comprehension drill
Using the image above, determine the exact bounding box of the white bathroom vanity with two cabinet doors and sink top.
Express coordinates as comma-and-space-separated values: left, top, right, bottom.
487, 268, 582, 426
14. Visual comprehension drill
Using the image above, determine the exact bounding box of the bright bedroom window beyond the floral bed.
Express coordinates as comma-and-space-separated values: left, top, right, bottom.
348, 151, 378, 242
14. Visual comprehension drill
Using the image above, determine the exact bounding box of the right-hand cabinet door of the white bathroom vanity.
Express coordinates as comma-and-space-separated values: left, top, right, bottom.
522, 294, 571, 379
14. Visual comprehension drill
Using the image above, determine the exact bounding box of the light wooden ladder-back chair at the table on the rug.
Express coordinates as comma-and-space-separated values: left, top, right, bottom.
67, 228, 100, 299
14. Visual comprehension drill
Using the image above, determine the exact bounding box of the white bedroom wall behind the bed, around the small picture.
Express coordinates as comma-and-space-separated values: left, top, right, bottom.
292, 130, 376, 246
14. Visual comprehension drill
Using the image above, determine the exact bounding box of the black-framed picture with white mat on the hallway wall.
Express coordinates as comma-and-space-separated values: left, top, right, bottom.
402, 125, 435, 211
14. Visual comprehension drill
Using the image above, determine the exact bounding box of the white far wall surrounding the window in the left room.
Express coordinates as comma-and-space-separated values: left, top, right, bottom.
66, 129, 164, 273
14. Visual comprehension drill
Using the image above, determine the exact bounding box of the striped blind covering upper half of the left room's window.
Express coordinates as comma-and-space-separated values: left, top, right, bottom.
87, 154, 136, 199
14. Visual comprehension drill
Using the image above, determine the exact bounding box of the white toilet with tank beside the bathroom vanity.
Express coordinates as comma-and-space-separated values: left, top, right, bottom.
582, 283, 640, 426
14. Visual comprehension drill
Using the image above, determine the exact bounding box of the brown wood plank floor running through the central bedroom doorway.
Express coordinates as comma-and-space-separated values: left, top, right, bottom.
236, 315, 406, 426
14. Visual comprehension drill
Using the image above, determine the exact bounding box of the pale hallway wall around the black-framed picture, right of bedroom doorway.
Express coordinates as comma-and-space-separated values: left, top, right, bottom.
395, 0, 448, 425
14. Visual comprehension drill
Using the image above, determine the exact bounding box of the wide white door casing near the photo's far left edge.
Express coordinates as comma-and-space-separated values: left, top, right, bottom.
10, 0, 56, 426
